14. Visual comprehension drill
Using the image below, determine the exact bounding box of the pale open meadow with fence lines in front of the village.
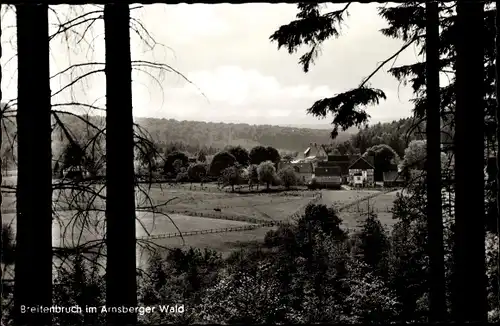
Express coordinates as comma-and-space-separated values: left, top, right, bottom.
2, 173, 395, 254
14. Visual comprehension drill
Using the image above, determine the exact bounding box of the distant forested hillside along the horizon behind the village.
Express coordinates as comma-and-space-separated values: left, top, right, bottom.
2, 114, 422, 168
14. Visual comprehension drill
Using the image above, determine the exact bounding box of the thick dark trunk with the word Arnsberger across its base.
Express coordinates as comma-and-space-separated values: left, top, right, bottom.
104, 3, 137, 325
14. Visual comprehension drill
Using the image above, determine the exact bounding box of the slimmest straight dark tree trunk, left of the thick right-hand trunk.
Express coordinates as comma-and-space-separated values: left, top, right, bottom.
425, 2, 446, 322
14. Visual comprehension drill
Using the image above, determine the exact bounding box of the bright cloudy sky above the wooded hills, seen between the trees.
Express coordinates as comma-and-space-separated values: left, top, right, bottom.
1, 3, 419, 125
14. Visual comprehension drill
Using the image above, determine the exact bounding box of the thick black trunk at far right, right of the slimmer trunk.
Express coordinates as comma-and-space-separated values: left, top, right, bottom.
453, 1, 488, 323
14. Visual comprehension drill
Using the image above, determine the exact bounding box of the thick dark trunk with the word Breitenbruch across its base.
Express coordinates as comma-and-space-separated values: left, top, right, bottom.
14, 4, 52, 325
